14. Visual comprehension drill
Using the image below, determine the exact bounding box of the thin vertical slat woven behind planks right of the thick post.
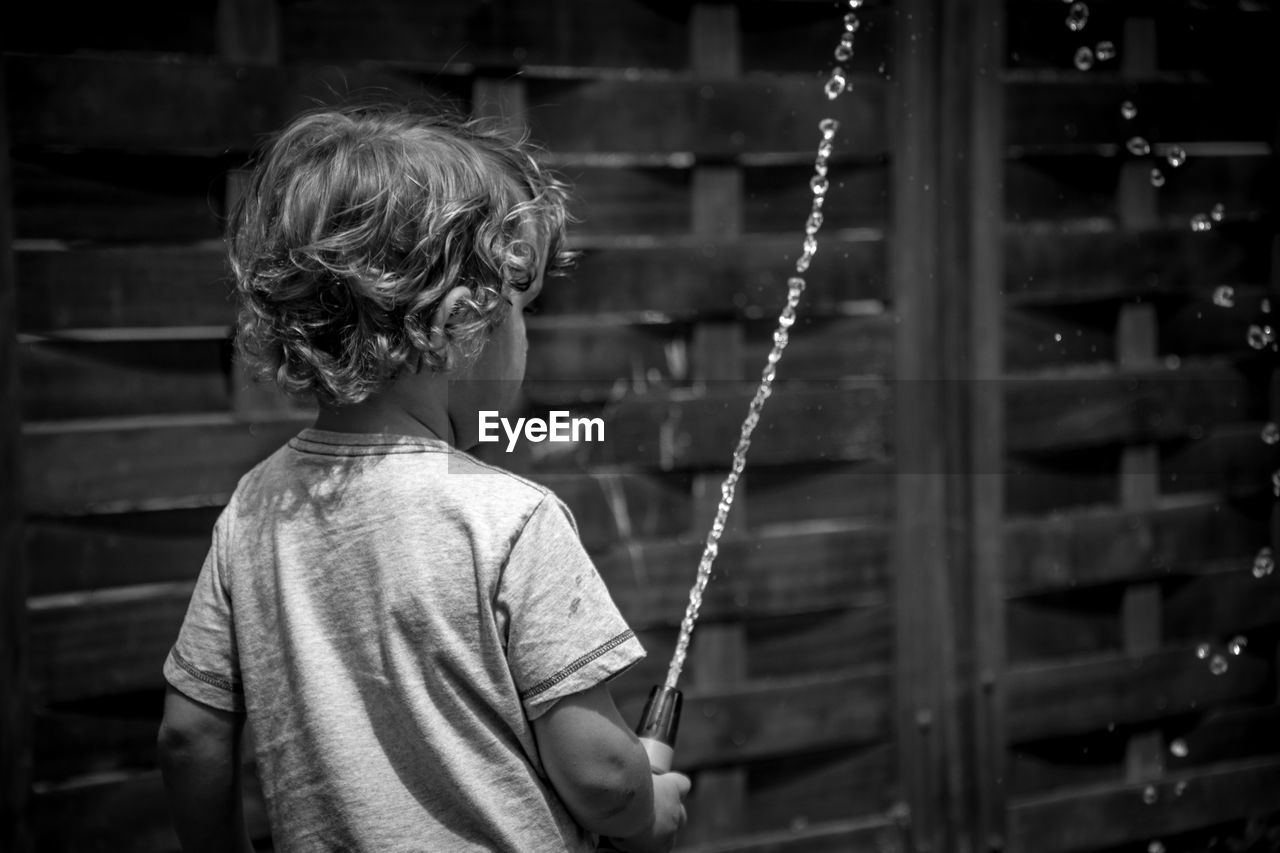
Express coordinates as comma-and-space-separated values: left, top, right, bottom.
1116, 18, 1165, 781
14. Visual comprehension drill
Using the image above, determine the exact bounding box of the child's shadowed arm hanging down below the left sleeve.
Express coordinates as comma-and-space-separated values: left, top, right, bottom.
157, 686, 253, 853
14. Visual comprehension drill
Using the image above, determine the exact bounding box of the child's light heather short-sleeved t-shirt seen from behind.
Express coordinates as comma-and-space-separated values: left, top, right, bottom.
164, 429, 644, 853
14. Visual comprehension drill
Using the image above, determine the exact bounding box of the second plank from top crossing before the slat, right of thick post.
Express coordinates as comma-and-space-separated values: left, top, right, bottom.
1005, 223, 1272, 305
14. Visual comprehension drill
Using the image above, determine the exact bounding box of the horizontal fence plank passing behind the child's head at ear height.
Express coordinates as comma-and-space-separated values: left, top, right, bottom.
17, 234, 884, 338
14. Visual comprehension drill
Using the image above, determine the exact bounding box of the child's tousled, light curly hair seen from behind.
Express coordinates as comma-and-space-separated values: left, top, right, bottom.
229, 106, 567, 406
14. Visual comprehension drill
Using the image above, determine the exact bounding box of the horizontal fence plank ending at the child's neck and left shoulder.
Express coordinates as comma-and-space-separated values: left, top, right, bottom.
23, 415, 307, 515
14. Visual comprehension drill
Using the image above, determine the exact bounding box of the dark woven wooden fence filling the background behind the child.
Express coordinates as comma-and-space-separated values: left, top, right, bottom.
0, 0, 1280, 853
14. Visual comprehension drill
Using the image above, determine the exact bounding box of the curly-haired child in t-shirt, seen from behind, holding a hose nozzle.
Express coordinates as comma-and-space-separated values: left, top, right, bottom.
159, 103, 689, 853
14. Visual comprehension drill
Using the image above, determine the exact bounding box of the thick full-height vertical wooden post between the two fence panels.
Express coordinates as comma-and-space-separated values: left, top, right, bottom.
890, 0, 1005, 853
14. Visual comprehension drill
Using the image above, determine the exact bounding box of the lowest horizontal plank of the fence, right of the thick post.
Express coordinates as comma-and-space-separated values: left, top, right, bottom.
1009, 758, 1280, 853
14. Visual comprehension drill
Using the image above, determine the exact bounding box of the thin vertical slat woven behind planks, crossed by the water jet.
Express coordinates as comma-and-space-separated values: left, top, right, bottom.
682, 4, 748, 843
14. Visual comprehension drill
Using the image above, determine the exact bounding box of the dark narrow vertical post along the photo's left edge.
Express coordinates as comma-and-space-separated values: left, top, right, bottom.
0, 54, 31, 853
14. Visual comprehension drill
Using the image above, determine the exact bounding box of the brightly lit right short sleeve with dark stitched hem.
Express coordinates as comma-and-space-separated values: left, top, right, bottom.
498, 494, 644, 720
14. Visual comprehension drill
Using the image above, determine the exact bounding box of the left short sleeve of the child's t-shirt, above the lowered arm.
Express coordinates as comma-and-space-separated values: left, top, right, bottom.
164, 512, 244, 712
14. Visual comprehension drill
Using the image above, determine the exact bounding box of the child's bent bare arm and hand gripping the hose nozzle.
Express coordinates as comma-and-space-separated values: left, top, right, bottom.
534, 683, 689, 853
